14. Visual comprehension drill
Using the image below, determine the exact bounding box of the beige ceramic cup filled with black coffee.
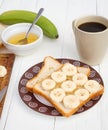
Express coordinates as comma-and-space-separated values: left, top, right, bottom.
72, 15, 108, 65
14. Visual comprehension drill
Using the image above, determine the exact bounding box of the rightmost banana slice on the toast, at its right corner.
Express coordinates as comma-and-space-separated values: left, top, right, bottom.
84, 80, 100, 93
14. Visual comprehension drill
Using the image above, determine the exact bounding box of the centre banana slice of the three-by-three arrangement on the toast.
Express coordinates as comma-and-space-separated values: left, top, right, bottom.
61, 80, 76, 93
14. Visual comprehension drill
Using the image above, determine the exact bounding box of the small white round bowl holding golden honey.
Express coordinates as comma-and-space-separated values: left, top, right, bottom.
1, 23, 43, 56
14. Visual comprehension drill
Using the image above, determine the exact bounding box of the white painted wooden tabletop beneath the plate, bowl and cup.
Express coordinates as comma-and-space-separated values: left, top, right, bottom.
0, 0, 108, 130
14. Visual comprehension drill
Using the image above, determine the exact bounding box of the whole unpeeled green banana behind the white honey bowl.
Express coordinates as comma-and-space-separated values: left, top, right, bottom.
0, 10, 58, 38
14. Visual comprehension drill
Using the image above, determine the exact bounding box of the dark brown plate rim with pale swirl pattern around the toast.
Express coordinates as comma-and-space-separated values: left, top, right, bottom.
18, 58, 104, 116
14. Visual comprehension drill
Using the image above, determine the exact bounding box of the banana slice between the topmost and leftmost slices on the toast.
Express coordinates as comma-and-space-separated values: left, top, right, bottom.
51, 71, 66, 83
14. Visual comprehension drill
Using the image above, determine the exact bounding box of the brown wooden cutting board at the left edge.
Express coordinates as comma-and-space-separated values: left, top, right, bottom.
0, 54, 15, 116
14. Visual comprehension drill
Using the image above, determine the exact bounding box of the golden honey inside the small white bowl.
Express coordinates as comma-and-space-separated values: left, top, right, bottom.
8, 32, 39, 45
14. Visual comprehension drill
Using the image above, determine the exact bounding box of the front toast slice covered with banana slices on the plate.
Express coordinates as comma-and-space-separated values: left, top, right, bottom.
33, 61, 104, 117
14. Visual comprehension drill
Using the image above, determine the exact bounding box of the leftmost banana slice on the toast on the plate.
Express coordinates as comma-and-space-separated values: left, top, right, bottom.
42, 79, 56, 90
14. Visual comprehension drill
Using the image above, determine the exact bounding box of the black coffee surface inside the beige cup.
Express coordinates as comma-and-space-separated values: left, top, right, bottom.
78, 22, 107, 32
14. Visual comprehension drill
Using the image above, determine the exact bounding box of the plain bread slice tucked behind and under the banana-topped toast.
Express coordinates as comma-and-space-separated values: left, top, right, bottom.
26, 56, 62, 92
